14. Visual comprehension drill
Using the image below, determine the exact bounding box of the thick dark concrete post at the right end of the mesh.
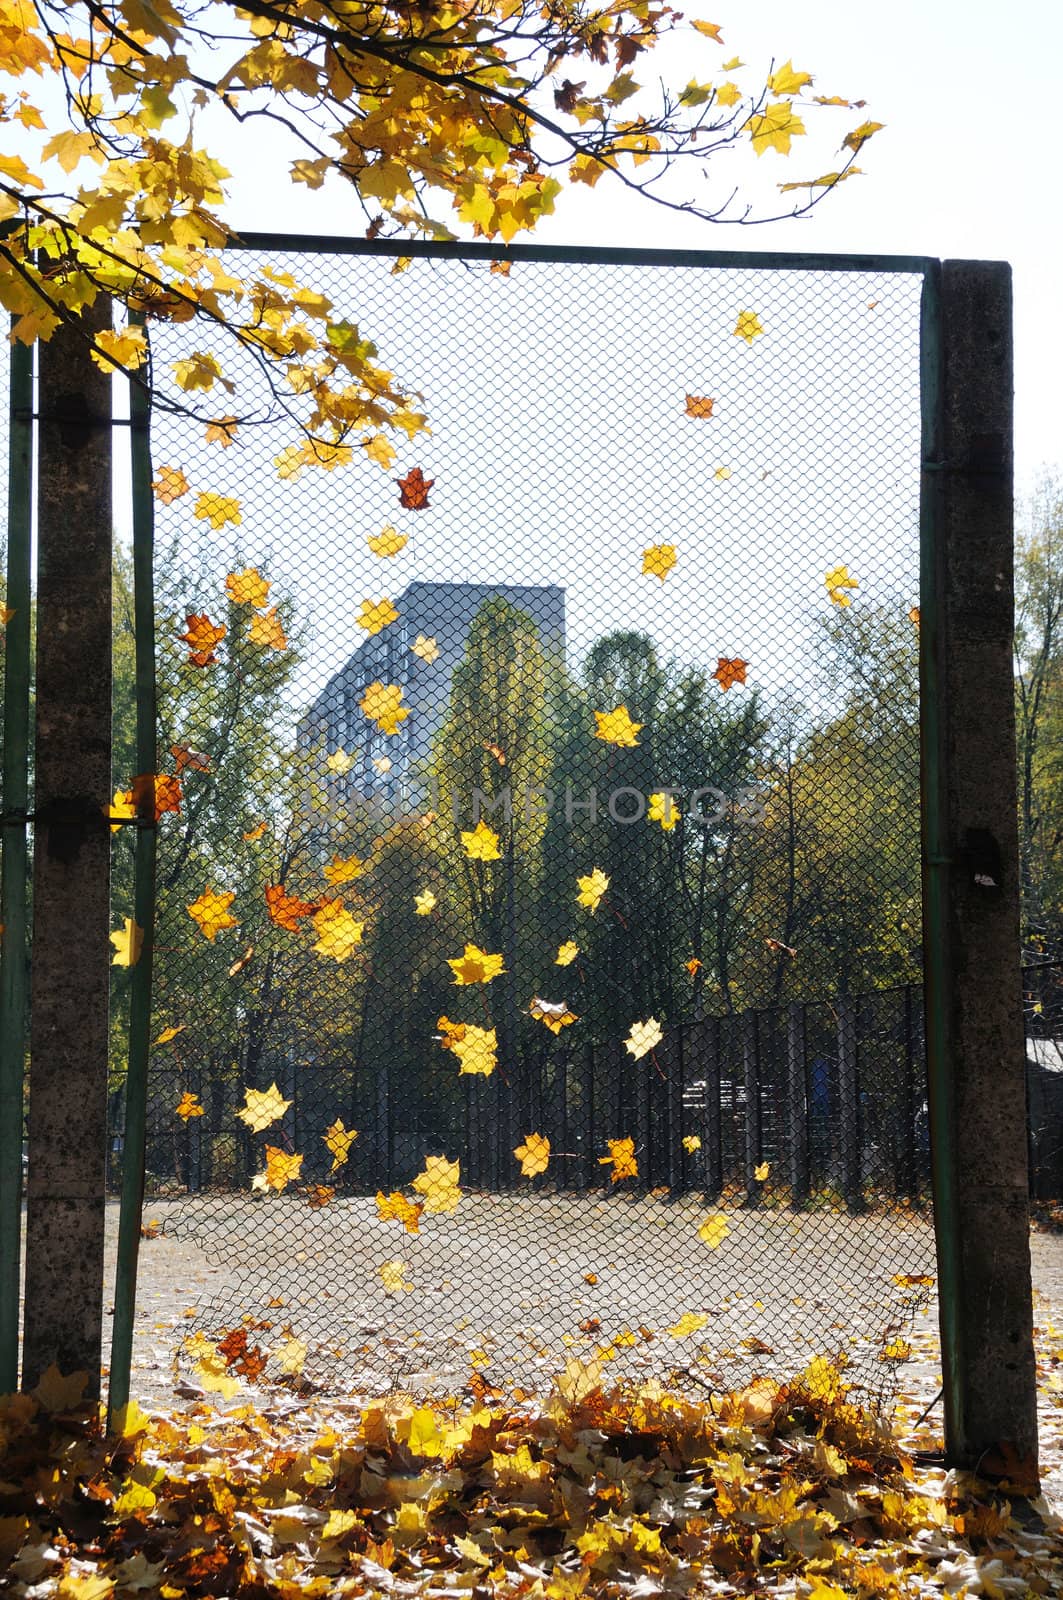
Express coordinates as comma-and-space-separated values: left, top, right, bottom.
924, 261, 1037, 1486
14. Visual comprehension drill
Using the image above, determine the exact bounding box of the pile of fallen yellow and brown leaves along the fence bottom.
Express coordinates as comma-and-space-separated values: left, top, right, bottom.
0, 1363, 1063, 1600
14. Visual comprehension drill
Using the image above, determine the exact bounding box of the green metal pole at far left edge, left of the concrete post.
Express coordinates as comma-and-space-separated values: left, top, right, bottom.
0, 334, 34, 1394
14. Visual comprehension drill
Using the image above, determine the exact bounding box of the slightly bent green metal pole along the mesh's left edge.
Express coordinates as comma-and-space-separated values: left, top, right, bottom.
107, 347, 155, 1427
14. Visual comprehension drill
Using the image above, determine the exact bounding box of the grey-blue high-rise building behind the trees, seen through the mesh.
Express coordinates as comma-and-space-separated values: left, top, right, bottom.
298, 582, 565, 811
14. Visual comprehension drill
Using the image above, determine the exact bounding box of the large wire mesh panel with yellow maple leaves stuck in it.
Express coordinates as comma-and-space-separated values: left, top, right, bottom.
114, 250, 933, 1397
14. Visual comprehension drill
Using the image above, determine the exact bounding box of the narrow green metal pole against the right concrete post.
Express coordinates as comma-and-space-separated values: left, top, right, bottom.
919, 262, 964, 1456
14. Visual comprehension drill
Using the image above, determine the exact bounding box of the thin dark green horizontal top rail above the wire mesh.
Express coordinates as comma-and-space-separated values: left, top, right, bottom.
226, 232, 940, 277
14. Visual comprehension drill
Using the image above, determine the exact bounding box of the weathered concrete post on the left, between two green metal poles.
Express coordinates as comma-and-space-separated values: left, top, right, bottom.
22, 302, 112, 1397
